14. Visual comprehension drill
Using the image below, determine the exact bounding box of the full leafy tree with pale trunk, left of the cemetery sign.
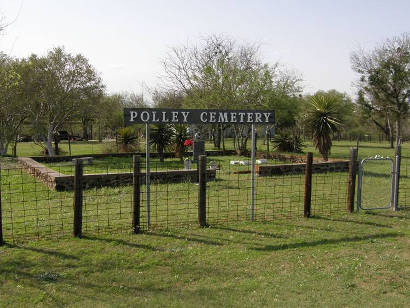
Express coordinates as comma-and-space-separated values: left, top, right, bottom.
26, 47, 104, 156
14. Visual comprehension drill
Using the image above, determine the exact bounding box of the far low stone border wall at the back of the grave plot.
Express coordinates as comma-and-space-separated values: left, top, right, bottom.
29, 150, 236, 163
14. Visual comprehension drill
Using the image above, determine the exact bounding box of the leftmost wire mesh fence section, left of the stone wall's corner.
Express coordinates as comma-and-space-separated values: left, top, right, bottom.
1, 163, 73, 240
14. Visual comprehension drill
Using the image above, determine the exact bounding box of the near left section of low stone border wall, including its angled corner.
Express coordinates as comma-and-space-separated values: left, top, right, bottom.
18, 157, 216, 191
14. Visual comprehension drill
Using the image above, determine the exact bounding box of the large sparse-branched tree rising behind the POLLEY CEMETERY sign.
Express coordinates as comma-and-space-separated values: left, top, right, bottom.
163, 35, 299, 152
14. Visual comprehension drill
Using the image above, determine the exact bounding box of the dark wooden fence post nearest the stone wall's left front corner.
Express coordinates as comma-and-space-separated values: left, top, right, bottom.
73, 159, 83, 237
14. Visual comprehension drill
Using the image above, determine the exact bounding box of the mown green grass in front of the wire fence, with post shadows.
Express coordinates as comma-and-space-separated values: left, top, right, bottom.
0, 211, 410, 307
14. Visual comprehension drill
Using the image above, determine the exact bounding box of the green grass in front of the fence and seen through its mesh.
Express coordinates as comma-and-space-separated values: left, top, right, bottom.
0, 142, 410, 307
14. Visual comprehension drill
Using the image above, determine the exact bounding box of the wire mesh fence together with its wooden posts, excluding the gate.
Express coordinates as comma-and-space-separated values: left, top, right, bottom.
0, 151, 410, 243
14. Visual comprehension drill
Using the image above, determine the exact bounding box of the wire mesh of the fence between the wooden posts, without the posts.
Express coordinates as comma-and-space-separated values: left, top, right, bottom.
0, 150, 404, 245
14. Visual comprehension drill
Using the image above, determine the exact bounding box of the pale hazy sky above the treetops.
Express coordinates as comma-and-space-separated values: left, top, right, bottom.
0, 0, 410, 98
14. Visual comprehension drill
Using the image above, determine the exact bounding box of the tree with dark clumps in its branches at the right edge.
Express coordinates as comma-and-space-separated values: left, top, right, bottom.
351, 33, 410, 144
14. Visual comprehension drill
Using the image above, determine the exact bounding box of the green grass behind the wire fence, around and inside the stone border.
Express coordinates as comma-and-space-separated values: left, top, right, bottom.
2, 143, 410, 241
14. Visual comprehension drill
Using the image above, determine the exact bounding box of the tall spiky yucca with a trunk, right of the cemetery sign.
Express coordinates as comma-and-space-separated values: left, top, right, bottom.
306, 95, 341, 161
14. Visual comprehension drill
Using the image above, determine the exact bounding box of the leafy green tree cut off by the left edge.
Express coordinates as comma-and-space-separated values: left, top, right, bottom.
0, 53, 28, 155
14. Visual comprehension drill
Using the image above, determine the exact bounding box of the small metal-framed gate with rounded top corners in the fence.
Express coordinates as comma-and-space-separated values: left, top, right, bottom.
357, 155, 394, 210
